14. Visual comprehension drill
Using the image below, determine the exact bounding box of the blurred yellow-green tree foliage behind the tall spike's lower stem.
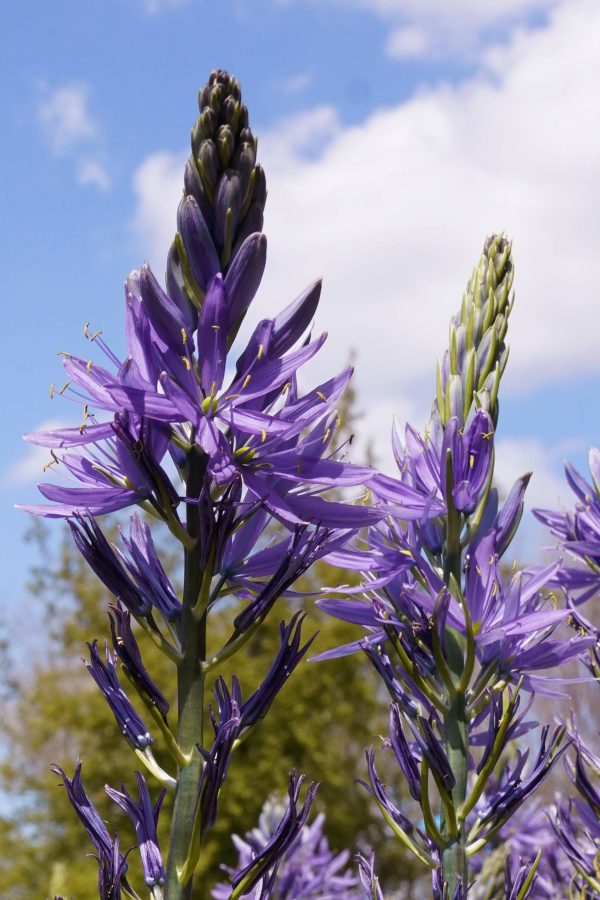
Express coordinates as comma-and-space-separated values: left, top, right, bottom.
0, 522, 422, 900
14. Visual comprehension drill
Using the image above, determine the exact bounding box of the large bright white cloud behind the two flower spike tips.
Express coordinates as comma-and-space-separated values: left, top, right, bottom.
135, 0, 600, 472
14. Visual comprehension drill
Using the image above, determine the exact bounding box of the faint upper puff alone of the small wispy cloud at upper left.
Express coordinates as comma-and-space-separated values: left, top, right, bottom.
37, 81, 98, 156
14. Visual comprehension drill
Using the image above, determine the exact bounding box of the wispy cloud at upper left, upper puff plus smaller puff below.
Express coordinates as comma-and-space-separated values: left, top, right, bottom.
36, 81, 111, 191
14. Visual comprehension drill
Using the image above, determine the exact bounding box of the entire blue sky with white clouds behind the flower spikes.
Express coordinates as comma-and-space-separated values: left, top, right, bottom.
0, 0, 600, 636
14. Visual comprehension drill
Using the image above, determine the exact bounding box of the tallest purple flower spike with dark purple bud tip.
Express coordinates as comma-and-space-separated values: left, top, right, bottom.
30, 71, 378, 898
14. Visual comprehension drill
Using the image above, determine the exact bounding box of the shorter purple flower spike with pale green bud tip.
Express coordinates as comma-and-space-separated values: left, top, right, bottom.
319, 237, 595, 898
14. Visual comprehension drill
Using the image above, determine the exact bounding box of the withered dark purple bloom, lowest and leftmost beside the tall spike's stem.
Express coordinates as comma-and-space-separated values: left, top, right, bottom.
50, 760, 128, 900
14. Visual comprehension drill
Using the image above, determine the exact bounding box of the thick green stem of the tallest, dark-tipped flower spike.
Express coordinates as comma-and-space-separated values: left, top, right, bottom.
165, 447, 206, 900
